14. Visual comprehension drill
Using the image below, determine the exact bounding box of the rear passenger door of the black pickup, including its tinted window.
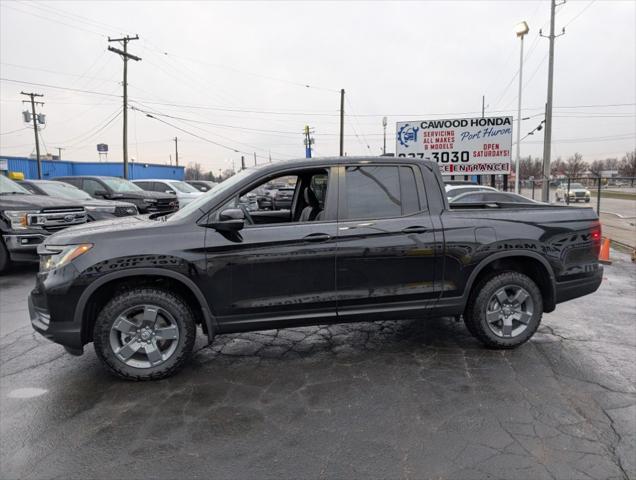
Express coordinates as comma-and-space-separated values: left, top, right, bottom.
336, 165, 439, 319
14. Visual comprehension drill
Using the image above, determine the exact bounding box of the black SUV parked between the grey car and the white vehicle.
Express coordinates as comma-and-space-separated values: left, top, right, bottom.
53, 176, 179, 213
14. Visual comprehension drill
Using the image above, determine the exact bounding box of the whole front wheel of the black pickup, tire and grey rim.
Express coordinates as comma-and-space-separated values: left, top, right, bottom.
93, 287, 196, 380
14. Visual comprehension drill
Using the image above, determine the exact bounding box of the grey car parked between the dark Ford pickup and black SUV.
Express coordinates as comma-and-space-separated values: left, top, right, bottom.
18, 180, 139, 222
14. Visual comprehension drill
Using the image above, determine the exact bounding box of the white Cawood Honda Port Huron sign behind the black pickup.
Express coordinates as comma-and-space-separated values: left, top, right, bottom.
395, 117, 512, 175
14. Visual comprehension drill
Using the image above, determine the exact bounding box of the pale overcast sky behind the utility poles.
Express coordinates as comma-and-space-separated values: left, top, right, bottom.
0, 0, 636, 172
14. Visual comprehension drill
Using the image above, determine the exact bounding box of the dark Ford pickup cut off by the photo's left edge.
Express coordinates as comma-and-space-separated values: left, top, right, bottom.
0, 175, 86, 273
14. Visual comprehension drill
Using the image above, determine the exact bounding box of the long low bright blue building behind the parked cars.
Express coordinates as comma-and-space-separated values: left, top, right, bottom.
0, 156, 185, 180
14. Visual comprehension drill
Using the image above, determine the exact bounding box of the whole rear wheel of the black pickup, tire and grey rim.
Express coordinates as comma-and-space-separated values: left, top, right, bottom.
464, 272, 543, 348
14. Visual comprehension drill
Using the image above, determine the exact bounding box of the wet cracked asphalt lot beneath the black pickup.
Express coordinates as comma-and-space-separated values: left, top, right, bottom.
0, 252, 636, 479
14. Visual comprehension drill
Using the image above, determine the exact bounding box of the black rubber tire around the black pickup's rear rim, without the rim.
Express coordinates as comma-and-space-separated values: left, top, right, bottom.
464, 271, 543, 349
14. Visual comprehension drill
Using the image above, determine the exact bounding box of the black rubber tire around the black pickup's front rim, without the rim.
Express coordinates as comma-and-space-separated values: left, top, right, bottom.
93, 287, 196, 381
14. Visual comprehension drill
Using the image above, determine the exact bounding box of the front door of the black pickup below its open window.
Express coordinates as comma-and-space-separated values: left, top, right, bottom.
206, 221, 337, 324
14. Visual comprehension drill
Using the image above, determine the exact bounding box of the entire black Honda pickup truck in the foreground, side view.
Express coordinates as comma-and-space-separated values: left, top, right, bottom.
29, 157, 603, 380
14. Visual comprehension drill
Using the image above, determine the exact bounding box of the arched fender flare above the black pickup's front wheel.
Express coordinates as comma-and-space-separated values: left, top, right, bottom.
73, 268, 217, 342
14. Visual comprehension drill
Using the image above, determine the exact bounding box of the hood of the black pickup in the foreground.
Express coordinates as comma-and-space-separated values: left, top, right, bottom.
44, 215, 159, 245
